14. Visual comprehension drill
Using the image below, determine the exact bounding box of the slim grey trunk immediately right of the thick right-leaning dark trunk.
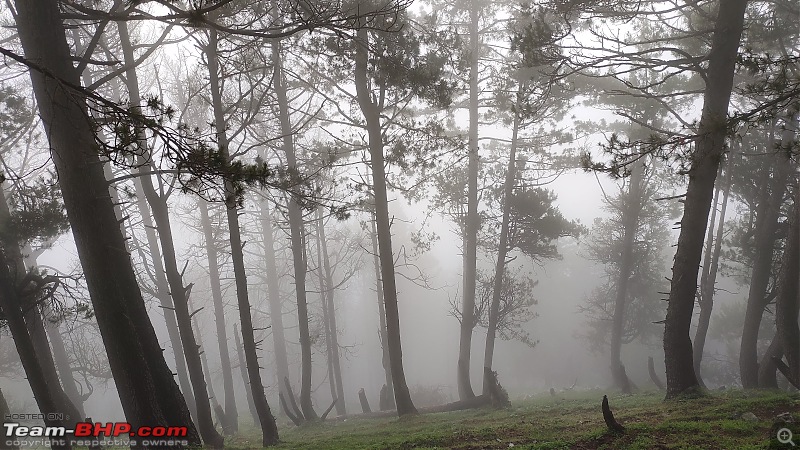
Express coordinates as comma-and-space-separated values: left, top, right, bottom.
692, 154, 734, 381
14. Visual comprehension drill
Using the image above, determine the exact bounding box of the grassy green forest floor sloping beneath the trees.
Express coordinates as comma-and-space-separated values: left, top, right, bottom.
226, 390, 800, 450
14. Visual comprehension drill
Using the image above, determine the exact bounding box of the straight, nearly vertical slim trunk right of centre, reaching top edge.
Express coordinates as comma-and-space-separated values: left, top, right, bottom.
458, 0, 481, 400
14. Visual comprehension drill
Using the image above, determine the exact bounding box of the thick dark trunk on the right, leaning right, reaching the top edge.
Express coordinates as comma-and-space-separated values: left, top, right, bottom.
664, 0, 747, 398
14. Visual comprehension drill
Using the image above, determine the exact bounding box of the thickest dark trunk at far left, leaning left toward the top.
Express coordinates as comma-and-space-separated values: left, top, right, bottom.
16, 0, 200, 445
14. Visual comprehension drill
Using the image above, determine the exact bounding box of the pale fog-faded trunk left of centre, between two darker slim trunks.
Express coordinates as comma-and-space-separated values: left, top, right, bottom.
259, 200, 294, 406
